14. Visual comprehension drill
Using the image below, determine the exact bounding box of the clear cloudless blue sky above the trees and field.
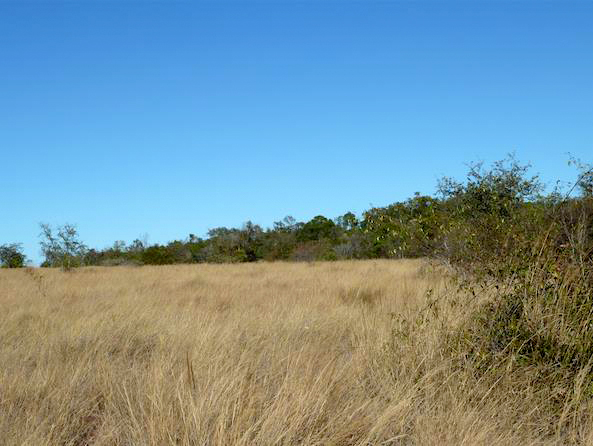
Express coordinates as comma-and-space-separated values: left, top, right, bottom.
0, 0, 593, 261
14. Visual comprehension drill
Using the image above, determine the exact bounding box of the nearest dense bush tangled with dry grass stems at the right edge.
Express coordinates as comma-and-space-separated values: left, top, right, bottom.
462, 197, 593, 366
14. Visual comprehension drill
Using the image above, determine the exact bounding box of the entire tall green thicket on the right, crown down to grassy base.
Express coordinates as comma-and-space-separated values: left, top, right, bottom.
441, 161, 593, 435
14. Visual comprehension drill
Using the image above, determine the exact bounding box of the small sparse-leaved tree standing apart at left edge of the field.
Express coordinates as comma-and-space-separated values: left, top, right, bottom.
39, 223, 87, 270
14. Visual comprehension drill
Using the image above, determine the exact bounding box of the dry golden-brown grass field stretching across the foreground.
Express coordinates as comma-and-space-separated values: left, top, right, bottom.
0, 260, 593, 446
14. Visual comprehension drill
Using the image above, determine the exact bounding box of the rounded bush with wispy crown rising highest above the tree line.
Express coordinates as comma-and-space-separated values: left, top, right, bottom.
437, 157, 546, 273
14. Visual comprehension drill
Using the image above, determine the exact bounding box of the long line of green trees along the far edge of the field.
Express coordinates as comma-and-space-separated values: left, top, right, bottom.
0, 156, 593, 269
